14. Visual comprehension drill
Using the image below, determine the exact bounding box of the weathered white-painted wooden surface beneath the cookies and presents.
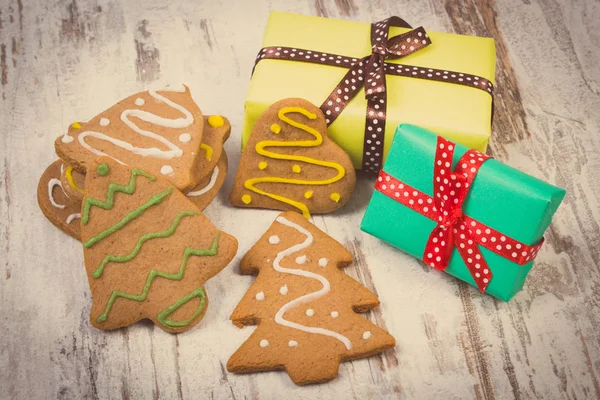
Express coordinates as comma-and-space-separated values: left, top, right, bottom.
0, 0, 600, 399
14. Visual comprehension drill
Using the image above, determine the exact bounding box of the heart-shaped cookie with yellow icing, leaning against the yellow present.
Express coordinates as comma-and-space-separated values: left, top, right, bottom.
229, 99, 356, 218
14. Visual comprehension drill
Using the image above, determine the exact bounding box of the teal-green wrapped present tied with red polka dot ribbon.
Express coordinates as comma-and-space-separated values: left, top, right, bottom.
361, 125, 565, 301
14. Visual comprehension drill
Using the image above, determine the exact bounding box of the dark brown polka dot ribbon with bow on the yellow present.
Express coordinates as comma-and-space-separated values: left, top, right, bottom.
254, 17, 494, 172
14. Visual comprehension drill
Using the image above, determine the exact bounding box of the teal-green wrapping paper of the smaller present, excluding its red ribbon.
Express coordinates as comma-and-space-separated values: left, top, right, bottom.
361, 125, 565, 301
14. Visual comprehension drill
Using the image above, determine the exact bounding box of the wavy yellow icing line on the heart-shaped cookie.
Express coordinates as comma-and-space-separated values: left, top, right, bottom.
244, 107, 346, 218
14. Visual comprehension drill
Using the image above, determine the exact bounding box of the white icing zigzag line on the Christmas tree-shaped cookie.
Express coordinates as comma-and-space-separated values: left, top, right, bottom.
273, 217, 352, 350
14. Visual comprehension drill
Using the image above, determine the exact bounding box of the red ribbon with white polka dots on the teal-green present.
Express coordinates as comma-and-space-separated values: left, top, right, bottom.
375, 137, 544, 292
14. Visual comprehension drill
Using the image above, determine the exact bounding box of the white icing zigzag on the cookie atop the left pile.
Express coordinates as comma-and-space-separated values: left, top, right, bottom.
63, 87, 194, 165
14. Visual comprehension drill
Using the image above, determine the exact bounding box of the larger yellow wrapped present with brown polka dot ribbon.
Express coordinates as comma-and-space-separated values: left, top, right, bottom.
242, 12, 496, 171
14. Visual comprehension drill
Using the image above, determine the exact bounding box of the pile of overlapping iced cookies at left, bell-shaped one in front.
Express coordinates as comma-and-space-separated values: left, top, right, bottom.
38, 86, 237, 332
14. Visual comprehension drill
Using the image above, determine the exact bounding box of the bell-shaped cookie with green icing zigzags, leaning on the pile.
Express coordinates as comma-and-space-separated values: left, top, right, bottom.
81, 157, 237, 332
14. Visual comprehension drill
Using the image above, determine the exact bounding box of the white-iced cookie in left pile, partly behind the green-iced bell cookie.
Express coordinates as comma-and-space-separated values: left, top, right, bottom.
55, 86, 210, 190
